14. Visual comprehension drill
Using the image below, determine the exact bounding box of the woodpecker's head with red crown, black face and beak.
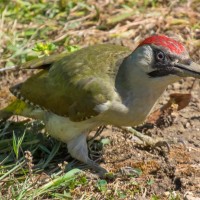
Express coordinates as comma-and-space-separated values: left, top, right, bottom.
129, 35, 200, 84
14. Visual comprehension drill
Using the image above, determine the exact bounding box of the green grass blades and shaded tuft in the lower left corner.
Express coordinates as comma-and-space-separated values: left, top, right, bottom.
0, 119, 87, 199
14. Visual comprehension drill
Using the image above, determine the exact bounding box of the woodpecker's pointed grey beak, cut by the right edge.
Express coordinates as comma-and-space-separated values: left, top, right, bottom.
173, 62, 200, 79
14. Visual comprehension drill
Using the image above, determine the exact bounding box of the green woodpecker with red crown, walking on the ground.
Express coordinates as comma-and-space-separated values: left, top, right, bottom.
0, 35, 200, 176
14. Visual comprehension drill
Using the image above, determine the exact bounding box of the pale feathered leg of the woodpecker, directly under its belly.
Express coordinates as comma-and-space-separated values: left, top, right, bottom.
67, 134, 107, 177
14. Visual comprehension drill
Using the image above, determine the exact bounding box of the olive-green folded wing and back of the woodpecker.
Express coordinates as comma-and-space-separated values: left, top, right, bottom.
11, 45, 130, 121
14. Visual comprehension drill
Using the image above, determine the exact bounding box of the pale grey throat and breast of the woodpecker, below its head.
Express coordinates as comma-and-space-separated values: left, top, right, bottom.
118, 69, 175, 126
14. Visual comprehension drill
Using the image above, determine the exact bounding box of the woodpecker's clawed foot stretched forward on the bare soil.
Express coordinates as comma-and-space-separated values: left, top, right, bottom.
123, 127, 186, 152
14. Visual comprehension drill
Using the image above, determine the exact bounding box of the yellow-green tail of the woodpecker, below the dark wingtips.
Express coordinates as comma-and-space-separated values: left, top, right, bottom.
0, 99, 27, 121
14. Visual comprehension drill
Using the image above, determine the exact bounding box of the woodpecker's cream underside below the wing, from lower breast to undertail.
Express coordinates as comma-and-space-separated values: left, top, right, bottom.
23, 97, 154, 143
